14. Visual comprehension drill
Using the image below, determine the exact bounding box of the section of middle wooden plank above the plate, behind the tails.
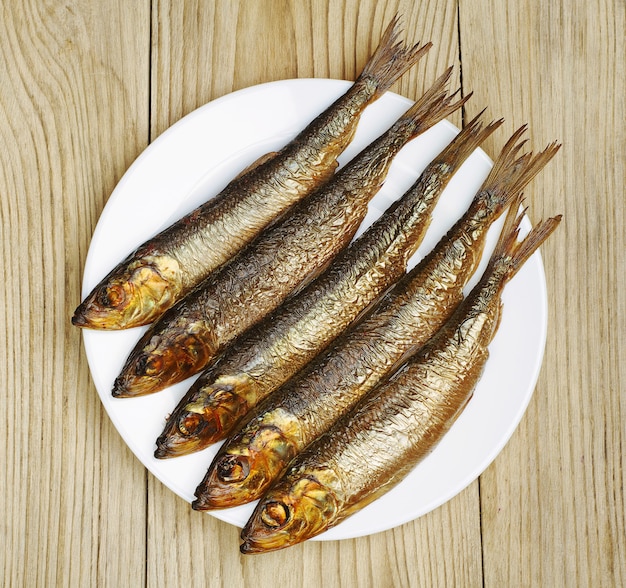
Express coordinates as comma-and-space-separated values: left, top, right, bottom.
151, 0, 460, 139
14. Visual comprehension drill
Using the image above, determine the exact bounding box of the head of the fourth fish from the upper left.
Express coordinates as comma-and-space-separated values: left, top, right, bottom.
194, 419, 299, 510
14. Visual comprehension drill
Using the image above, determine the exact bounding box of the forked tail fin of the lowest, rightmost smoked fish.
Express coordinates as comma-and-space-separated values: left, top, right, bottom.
490, 201, 562, 282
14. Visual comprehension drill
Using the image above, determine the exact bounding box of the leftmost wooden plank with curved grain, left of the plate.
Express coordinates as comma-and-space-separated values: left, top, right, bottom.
0, 1, 150, 586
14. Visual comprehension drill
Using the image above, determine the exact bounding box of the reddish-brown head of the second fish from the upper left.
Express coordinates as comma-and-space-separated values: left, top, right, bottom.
112, 320, 217, 398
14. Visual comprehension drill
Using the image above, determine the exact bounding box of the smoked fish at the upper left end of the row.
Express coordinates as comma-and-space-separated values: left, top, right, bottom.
71, 16, 432, 330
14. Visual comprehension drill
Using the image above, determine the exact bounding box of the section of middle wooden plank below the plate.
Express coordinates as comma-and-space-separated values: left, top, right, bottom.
147, 477, 482, 588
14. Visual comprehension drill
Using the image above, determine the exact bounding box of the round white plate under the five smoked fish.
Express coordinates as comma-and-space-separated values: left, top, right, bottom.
83, 79, 546, 539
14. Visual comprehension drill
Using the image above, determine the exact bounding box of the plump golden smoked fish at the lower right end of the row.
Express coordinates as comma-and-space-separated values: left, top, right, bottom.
240, 206, 561, 554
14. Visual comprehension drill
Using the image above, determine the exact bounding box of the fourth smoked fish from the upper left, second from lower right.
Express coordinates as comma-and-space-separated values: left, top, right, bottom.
193, 128, 559, 510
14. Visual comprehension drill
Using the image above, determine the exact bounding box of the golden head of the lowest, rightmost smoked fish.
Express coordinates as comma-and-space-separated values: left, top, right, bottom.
240, 469, 339, 554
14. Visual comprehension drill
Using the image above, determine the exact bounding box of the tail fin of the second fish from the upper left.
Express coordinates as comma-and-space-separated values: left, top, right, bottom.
394, 67, 472, 136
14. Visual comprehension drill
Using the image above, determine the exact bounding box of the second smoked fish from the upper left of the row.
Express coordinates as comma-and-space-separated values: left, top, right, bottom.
113, 68, 467, 397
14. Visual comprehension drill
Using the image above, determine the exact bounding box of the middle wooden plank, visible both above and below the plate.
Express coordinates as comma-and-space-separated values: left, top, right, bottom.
147, 0, 482, 586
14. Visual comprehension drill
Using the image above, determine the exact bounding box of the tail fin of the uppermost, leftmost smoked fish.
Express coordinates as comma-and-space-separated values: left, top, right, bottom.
357, 14, 432, 96
